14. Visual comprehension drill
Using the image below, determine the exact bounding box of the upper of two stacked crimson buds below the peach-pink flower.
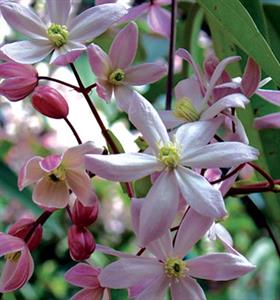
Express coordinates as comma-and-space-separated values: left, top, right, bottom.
72, 200, 99, 227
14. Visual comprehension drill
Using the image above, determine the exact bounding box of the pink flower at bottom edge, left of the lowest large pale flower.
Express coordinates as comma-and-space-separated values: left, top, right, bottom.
64, 263, 105, 300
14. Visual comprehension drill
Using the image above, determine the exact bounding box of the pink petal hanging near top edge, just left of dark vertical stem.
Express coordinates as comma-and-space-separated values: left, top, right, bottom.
148, 5, 171, 38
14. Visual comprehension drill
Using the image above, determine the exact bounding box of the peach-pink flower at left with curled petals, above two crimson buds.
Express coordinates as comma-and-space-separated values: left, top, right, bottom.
18, 142, 102, 209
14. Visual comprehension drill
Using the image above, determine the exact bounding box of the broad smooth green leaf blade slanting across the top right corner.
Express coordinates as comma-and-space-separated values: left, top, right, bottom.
198, 0, 280, 86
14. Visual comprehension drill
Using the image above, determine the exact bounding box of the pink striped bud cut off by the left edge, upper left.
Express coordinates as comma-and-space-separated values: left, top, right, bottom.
0, 62, 38, 101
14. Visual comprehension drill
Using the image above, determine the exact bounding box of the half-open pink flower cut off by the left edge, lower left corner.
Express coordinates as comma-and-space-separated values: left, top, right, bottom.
0, 232, 34, 293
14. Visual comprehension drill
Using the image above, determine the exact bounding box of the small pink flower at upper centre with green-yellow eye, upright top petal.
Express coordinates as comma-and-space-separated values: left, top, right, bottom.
88, 23, 167, 111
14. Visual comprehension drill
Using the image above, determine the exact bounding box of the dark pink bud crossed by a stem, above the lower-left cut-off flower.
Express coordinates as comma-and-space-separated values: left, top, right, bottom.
8, 218, 43, 251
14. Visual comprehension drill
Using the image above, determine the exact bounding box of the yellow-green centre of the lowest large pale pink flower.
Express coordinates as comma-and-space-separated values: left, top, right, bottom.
164, 257, 188, 280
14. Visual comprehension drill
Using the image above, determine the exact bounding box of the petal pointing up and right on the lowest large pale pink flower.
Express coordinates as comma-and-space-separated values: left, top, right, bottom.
174, 208, 213, 257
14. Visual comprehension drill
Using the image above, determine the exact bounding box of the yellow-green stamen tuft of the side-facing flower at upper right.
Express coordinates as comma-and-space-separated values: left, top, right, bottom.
173, 97, 200, 122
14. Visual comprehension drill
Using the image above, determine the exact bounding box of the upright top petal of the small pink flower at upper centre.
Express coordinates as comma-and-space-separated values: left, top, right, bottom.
109, 23, 138, 69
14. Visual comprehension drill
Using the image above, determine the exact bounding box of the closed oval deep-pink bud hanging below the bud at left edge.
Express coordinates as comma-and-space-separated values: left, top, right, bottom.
32, 85, 69, 119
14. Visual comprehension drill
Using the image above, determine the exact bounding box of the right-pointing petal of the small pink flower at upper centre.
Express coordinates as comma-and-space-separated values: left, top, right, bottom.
124, 63, 167, 85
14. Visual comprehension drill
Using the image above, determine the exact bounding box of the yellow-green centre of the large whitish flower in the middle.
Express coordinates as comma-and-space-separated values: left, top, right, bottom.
158, 143, 180, 169
